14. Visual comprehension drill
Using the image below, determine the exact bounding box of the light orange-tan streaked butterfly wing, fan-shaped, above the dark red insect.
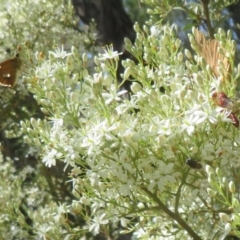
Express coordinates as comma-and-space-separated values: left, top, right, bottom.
195, 29, 232, 79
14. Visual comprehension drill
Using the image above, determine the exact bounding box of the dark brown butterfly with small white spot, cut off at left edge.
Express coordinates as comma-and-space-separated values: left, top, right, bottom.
0, 54, 22, 88
